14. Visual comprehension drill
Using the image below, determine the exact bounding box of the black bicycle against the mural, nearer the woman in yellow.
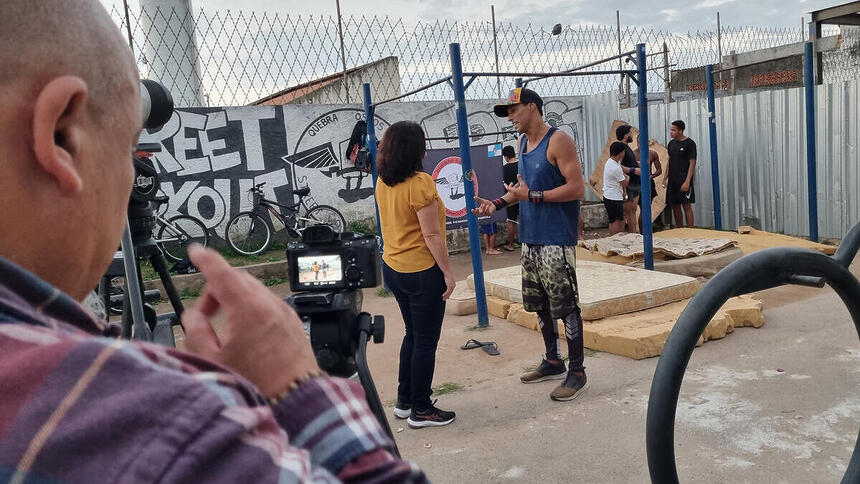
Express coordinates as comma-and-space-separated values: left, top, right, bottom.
224, 182, 346, 255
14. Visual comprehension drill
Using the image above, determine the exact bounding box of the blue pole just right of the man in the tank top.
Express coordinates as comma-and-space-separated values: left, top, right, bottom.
636, 44, 654, 270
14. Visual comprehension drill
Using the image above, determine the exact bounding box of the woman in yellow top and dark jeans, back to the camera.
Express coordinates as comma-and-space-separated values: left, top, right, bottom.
376, 121, 455, 428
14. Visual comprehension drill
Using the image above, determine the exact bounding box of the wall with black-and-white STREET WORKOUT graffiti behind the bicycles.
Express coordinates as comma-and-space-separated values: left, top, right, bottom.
140, 98, 584, 237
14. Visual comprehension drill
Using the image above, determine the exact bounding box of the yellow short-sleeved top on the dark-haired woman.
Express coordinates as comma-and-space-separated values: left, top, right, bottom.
376, 172, 445, 272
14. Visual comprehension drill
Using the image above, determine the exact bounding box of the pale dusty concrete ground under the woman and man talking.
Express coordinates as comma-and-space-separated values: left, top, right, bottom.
165, 244, 860, 483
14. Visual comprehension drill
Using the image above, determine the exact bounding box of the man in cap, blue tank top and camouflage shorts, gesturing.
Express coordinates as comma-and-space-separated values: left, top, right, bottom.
475, 88, 588, 401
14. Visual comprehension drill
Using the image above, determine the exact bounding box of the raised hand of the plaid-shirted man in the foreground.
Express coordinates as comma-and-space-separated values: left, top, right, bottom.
182, 245, 319, 397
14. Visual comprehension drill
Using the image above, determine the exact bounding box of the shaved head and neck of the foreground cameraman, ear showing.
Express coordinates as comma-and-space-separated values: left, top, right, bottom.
0, 0, 141, 300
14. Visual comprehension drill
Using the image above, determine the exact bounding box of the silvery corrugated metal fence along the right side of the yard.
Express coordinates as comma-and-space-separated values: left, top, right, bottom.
585, 81, 860, 237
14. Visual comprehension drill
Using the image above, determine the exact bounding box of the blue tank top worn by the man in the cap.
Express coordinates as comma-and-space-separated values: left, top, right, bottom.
520, 128, 579, 245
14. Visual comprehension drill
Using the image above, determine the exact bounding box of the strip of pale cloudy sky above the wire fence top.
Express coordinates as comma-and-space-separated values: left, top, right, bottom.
106, 0, 844, 32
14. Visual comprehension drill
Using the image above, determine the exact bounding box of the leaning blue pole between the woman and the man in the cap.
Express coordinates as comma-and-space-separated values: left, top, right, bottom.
450, 43, 490, 327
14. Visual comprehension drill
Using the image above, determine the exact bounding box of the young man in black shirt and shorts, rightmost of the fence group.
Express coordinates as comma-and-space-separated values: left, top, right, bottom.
663, 120, 696, 227
